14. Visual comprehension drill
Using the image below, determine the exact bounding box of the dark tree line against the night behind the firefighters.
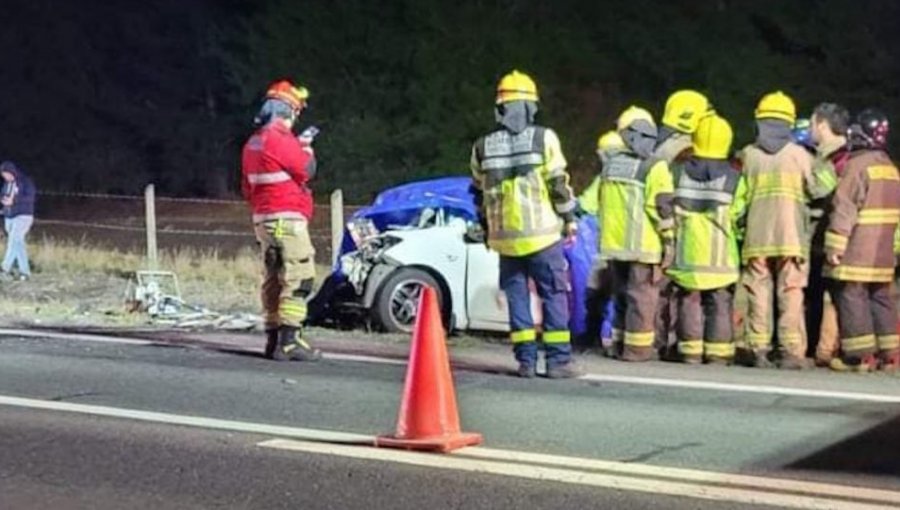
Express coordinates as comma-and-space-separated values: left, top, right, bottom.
0, 0, 900, 201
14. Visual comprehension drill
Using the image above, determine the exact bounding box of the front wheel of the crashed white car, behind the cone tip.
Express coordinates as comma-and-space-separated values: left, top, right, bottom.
373, 268, 445, 333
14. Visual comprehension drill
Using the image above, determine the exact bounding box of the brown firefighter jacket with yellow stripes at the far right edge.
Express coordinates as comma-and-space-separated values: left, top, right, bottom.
825, 151, 900, 282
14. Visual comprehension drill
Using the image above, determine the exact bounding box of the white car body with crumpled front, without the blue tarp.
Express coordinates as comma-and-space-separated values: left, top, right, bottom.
330, 209, 540, 332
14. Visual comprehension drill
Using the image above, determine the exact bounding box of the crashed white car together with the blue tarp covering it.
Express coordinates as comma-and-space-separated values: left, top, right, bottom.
310, 177, 597, 334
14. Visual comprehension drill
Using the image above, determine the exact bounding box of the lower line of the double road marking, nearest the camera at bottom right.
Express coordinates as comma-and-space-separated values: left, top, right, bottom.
259, 439, 900, 510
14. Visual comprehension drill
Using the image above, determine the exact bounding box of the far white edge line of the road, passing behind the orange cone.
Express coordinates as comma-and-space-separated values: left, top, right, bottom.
0, 329, 900, 404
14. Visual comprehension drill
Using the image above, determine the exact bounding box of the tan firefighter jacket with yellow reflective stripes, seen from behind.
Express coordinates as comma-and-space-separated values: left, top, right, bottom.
742, 143, 830, 262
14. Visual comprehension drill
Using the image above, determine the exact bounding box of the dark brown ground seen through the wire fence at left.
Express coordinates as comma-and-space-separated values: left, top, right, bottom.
32, 191, 360, 264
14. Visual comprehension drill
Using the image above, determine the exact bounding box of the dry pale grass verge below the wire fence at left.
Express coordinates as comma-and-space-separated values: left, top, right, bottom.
0, 237, 328, 323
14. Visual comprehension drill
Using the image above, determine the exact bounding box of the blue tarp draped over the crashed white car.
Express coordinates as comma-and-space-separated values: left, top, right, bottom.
341, 177, 597, 335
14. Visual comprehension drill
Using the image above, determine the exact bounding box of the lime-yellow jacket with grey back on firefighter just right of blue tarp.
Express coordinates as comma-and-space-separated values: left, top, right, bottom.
597, 153, 674, 264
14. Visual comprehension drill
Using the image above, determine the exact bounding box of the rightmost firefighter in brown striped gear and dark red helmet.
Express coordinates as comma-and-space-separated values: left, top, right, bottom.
825, 109, 900, 372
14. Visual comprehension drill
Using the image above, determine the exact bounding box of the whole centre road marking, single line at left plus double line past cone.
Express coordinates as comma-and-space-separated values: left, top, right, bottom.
0, 395, 900, 510
